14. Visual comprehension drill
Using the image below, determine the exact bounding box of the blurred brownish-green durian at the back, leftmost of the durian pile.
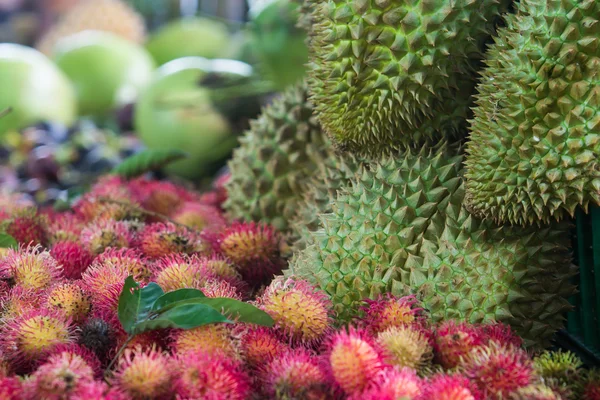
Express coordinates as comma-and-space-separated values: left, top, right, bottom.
224, 84, 330, 231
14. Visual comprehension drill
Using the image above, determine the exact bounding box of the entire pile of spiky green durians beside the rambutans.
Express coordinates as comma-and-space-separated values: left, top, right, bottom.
226, 0, 600, 345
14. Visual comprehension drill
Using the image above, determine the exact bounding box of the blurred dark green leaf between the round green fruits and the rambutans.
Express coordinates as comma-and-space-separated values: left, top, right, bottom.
113, 150, 188, 179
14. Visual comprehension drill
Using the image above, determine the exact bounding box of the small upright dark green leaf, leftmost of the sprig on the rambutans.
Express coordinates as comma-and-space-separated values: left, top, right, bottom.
118, 276, 164, 334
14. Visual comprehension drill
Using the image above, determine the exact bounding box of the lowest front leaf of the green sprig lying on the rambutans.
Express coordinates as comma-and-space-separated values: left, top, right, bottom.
132, 303, 233, 335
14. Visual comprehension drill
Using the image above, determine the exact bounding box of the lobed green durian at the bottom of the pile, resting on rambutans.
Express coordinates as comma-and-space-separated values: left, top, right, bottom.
289, 143, 574, 344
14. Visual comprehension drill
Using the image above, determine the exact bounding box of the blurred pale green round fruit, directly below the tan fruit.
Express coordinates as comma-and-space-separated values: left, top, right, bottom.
54, 31, 154, 115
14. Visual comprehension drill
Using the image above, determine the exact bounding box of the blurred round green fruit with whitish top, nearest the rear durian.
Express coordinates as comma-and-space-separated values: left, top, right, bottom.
134, 57, 252, 179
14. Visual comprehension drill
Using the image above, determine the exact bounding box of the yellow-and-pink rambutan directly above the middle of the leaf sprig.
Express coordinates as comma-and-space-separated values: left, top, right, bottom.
154, 254, 205, 292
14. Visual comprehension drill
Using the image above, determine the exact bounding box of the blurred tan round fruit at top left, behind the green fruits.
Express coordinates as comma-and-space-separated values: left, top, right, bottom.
36, 0, 146, 55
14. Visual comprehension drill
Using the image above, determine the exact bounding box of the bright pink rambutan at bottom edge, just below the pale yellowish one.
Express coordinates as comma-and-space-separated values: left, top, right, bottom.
348, 368, 422, 400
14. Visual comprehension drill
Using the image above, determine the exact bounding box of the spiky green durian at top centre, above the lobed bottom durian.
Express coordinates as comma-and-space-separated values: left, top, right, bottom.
308, 0, 512, 154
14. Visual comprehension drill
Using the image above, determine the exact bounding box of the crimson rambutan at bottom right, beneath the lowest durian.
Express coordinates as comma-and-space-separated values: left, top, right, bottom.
459, 341, 534, 398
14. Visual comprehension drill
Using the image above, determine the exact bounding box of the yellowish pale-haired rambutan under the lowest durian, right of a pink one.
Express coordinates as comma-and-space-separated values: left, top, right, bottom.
376, 325, 433, 370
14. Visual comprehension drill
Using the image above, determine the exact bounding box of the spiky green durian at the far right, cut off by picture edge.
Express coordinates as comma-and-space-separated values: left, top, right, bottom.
465, 0, 600, 225
